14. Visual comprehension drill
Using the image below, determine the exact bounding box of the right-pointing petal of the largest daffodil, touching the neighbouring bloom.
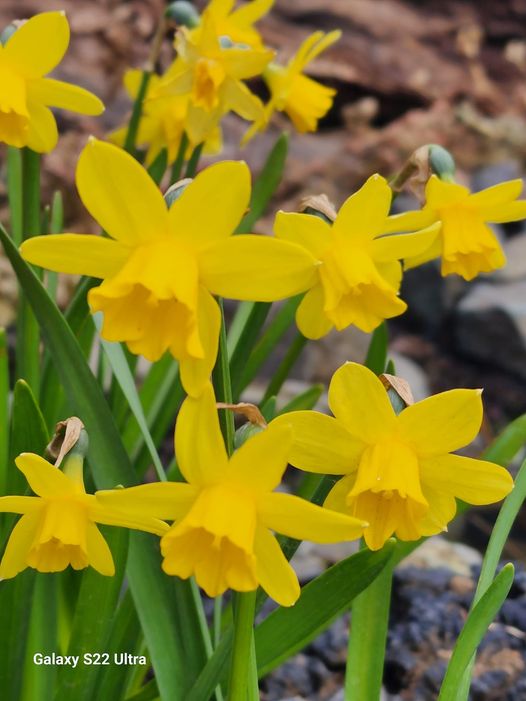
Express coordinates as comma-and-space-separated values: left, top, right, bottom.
199, 234, 316, 302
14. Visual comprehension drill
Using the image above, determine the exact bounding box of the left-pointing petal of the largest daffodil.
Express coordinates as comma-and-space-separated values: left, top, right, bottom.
20, 234, 131, 278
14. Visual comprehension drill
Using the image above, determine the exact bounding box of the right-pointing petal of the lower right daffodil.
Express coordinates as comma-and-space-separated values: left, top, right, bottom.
420, 455, 513, 505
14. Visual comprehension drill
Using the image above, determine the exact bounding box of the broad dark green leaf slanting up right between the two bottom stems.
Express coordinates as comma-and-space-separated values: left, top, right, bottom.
255, 543, 393, 676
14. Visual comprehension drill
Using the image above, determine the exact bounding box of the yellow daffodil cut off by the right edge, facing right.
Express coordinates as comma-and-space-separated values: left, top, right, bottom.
389, 175, 526, 280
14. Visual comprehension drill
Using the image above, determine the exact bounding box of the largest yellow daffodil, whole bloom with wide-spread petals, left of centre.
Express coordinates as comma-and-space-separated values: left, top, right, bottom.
21, 139, 315, 394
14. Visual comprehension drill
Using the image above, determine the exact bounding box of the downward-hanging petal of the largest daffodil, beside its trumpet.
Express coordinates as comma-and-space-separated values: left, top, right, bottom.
176, 285, 221, 397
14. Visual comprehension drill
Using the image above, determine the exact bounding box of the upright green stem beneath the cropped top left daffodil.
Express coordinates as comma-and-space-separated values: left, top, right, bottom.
16, 148, 40, 399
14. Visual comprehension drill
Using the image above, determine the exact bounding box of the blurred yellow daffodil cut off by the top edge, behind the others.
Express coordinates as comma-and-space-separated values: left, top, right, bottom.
203, 0, 274, 48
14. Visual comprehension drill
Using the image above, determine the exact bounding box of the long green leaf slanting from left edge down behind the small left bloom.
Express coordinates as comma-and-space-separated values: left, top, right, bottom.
0, 227, 191, 701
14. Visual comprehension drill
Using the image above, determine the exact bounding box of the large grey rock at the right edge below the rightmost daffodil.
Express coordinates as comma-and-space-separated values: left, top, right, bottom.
453, 281, 526, 379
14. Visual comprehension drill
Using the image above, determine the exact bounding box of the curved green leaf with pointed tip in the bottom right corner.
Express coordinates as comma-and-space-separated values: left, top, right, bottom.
438, 563, 515, 701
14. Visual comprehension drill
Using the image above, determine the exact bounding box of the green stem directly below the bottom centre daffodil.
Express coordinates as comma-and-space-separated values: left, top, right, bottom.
228, 591, 256, 701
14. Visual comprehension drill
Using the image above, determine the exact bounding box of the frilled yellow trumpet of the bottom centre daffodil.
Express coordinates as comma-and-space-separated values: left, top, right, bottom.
161, 485, 258, 596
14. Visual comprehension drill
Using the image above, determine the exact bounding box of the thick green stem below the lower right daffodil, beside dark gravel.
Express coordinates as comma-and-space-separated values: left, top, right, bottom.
345, 544, 393, 701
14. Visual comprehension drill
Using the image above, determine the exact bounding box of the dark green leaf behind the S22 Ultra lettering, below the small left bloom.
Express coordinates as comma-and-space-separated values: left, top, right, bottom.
55, 528, 130, 701
